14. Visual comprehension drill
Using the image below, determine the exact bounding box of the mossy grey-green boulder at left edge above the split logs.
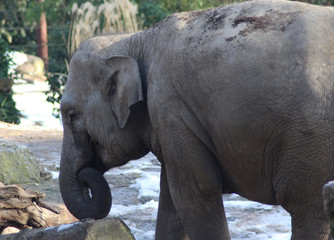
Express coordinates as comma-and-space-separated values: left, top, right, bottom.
0, 141, 40, 184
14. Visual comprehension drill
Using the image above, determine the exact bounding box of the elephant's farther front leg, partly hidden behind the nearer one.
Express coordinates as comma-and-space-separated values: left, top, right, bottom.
155, 165, 187, 240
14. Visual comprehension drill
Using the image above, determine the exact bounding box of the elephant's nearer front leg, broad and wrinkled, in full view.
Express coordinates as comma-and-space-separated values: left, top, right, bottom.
158, 127, 230, 240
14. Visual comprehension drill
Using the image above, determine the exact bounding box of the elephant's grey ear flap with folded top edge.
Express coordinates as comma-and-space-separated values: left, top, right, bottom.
107, 56, 143, 128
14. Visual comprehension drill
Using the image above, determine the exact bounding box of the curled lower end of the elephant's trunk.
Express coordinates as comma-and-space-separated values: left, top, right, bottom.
59, 165, 112, 220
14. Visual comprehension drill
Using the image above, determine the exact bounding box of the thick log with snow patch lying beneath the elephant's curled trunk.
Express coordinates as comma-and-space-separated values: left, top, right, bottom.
0, 218, 135, 240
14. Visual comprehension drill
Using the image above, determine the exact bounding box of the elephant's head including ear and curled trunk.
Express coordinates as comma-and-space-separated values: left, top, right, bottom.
59, 39, 148, 219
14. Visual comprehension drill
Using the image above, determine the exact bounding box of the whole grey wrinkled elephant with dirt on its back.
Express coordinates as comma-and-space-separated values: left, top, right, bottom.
60, 1, 334, 240
